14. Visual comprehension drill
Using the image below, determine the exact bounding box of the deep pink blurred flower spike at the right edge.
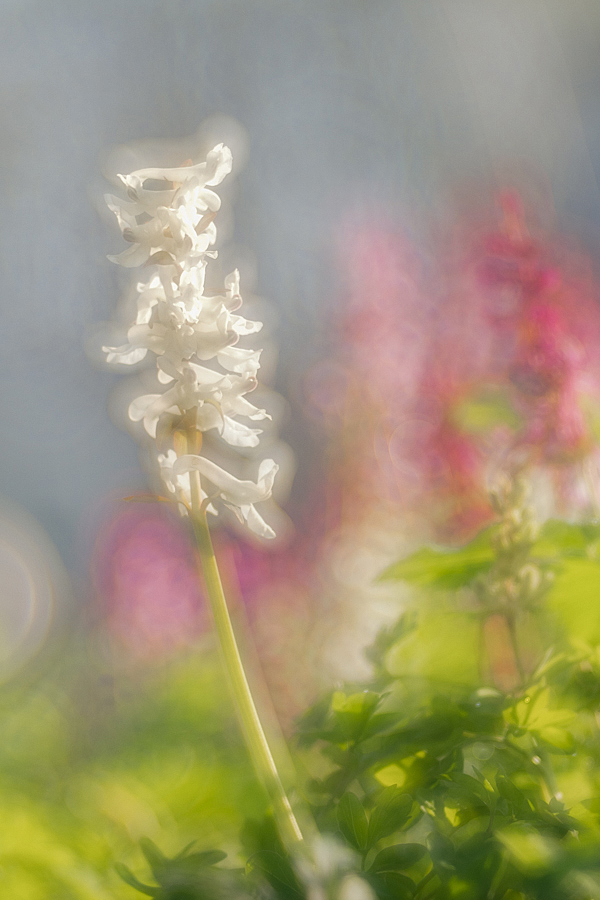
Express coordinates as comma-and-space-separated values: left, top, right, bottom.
481, 193, 600, 466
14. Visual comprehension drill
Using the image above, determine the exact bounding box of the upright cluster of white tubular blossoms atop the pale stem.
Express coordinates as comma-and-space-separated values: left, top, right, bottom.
103, 144, 278, 538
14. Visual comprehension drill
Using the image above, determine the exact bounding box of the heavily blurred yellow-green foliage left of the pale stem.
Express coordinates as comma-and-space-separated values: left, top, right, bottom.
0, 638, 266, 900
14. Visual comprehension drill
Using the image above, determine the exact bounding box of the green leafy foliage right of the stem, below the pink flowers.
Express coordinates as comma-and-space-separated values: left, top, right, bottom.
292, 500, 600, 900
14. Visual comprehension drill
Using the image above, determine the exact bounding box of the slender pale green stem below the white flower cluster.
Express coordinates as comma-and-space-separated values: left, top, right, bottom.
190, 472, 303, 849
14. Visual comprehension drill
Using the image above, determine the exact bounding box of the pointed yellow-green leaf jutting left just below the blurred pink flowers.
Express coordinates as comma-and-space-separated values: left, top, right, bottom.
377, 528, 494, 590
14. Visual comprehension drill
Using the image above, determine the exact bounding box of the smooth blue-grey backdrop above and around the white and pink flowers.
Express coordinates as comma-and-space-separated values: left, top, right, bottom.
0, 0, 600, 566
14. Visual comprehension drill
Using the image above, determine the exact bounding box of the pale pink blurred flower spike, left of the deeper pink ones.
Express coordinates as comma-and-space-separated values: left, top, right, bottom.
308, 221, 432, 526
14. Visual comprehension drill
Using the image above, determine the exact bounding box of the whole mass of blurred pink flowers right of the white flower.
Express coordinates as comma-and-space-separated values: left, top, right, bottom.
321, 191, 600, 540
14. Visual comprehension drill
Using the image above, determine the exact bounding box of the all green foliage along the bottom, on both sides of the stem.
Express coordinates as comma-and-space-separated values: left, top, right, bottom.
5, 482, 600, 900
